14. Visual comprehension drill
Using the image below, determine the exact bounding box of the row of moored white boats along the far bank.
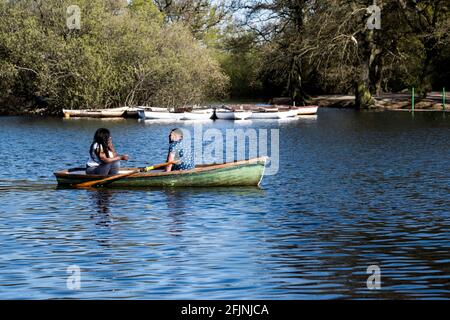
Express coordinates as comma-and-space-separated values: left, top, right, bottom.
63, 104, 318, 121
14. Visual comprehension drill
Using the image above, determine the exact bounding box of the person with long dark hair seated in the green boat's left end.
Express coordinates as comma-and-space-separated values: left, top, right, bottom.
86, 128, 128, 176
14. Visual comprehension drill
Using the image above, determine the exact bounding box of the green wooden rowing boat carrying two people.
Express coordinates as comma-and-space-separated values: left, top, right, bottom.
54, 157, 268, 188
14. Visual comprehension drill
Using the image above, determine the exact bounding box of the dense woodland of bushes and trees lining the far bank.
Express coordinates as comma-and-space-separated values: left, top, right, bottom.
0, 0, 450, 113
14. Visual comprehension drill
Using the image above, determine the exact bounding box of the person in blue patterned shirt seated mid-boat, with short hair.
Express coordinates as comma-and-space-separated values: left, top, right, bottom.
166, 129, 195, 172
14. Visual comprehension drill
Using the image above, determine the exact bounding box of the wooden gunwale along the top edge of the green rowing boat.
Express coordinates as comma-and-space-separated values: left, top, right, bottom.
54, 156, 269, 180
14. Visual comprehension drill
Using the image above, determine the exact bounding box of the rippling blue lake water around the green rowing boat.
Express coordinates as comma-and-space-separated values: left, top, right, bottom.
0, 109, 450, 299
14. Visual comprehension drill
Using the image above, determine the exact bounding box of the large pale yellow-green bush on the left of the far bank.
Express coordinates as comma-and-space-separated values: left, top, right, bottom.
0, 0, 228, 112
